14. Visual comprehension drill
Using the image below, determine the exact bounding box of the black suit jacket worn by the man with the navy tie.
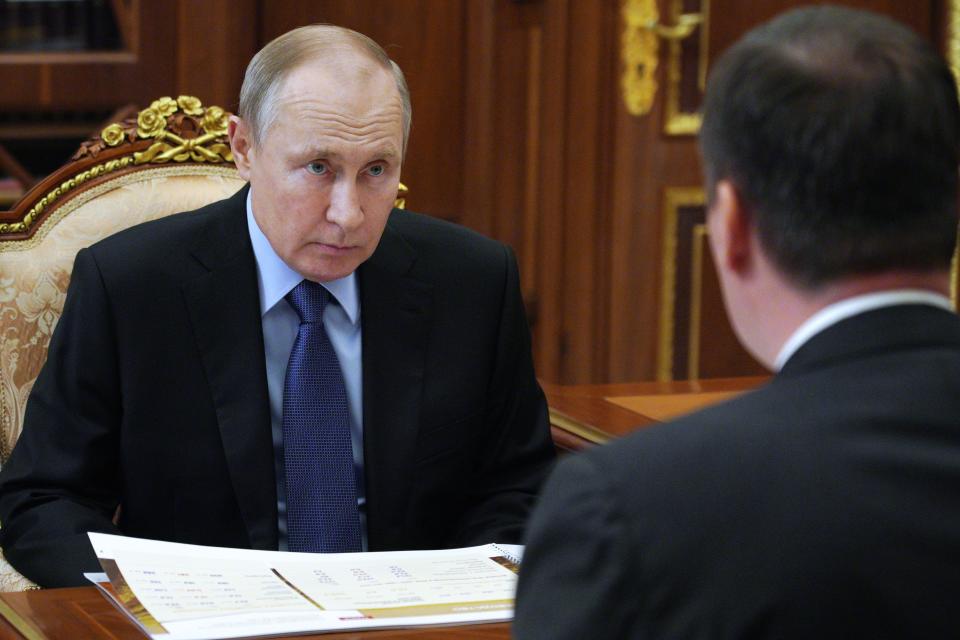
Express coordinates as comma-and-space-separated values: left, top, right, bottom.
0, 189, 553, 586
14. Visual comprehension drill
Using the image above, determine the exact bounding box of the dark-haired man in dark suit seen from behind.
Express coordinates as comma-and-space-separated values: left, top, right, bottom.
515, 7, 960, 640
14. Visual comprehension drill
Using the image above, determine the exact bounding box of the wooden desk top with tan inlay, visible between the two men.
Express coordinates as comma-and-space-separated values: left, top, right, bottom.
541, 376, 768, 451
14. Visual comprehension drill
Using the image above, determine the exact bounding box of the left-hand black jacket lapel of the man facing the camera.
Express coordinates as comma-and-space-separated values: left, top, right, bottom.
183, 188, 277, 549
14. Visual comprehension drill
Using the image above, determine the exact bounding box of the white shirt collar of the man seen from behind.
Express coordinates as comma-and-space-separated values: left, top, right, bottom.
774, 289, 953, 371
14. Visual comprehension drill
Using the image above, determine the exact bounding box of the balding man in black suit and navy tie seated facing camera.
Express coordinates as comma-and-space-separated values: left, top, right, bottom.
0, 26, 553, 586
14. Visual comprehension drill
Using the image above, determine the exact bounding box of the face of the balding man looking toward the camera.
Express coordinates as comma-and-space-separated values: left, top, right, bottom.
230, 63, 403, 282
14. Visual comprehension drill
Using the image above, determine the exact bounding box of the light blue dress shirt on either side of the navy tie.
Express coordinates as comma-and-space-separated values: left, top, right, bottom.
247, 193, 367, 551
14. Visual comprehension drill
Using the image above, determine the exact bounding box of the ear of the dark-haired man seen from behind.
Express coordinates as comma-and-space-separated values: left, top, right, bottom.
707, 180, 755, 275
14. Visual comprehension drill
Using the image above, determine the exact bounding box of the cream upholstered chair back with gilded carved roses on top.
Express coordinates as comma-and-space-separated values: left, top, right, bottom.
0, 96, 244, 591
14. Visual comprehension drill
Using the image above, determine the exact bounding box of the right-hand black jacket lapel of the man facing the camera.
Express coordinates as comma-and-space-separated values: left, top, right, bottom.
358, 216, 433, 549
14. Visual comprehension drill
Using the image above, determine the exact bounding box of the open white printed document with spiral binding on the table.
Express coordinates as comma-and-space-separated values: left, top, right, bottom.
88, 533, 523, 640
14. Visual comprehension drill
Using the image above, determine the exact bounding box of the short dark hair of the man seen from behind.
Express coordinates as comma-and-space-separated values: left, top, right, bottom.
700, 6, 960, 288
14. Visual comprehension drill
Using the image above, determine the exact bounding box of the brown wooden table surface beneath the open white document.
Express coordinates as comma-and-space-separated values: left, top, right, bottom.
0, 587, 510, 640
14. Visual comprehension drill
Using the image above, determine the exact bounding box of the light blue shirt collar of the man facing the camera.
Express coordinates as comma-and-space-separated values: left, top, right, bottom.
247, 189, 360, 325
